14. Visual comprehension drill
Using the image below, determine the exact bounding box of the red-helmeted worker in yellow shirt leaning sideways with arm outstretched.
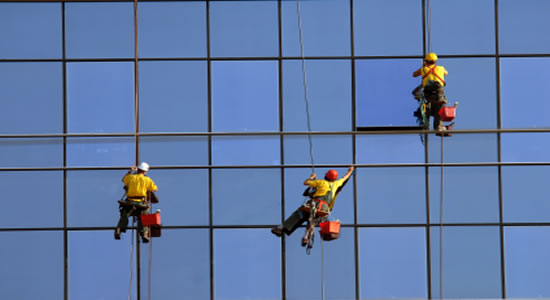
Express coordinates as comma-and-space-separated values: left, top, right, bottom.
271, 166, 354, 247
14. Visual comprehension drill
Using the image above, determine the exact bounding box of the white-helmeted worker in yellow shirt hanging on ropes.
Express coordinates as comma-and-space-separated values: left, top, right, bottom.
115, 162, 158, 243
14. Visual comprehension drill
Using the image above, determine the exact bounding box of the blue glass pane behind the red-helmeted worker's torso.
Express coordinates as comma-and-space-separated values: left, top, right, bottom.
284, 168, 354, 224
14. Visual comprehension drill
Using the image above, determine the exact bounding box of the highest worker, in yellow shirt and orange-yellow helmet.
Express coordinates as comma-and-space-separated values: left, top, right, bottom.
413, 53, 449, 131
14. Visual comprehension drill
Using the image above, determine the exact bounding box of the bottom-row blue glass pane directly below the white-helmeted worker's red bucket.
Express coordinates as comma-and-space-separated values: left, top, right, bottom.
141, 229, 210, 300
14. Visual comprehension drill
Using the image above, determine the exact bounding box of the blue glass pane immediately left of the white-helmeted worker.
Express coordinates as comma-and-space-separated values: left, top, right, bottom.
67, 170, 129, 226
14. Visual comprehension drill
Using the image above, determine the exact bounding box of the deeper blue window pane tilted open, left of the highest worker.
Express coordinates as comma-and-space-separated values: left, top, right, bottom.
355, 59, 421, 127
